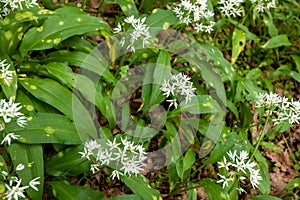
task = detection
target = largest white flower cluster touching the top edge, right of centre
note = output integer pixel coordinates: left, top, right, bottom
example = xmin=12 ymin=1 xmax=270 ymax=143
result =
xmin=173 ymin=0 xmax=215 ymax=33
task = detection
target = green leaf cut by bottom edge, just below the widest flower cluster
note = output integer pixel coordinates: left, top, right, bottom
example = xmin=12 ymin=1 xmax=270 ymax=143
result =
xmin=121 ymin=175 xmax=162 ymax=200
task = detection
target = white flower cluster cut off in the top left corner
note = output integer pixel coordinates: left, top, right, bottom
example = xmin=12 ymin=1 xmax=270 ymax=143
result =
xmin=0 ymin=0 xmax=39 ymax=18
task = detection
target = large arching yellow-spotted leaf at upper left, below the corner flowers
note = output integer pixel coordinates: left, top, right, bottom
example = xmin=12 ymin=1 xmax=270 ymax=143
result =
xmin=20 ymin=7 xmax=110 ymax=56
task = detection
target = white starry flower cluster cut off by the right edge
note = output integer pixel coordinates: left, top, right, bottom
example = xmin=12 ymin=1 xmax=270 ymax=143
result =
xmin=256 ymin=92 xmax=300 ymax=124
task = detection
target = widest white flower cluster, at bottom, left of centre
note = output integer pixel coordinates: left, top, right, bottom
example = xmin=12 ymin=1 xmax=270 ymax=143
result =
xmin=79 ymin=138 xmax=146 ymax=179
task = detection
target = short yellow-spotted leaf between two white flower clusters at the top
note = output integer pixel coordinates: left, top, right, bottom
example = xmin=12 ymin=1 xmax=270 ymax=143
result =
xmin=146 ymin=9 xmax=178 ymax=29
